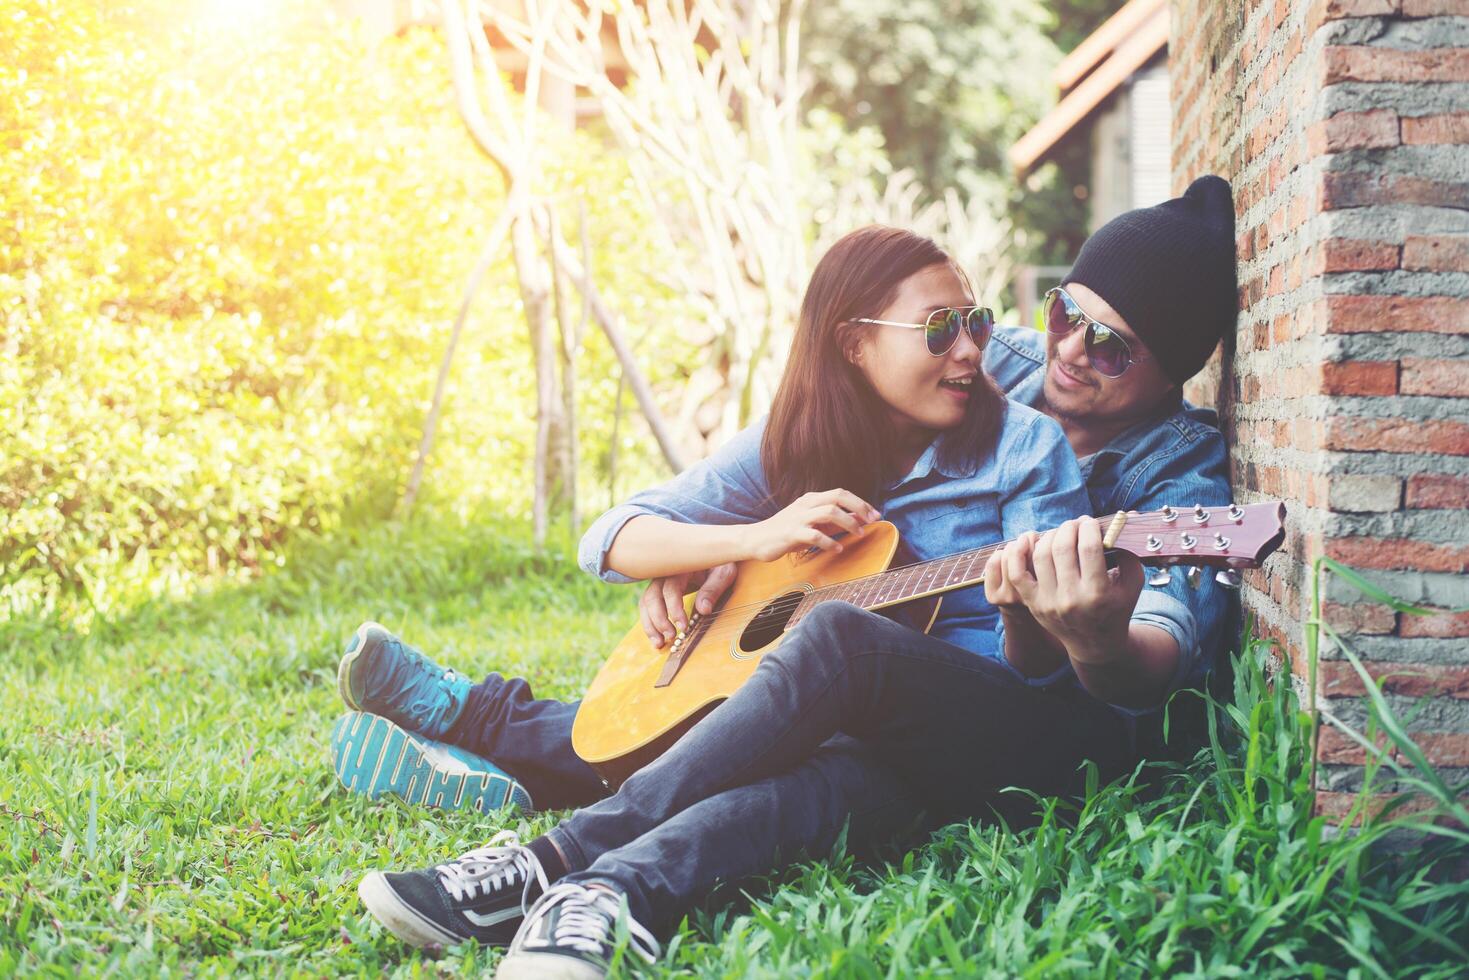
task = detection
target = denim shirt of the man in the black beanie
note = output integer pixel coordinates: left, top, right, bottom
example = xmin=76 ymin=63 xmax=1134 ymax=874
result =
xmin=984 ymin=326 xmax=1235 ymax=705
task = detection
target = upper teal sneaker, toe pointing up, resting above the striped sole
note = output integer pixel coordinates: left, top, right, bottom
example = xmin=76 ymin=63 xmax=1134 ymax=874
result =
xmin=336 ymin=623 xmax=473 ymax=739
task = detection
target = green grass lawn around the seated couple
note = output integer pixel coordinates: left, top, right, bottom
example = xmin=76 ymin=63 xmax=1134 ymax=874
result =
xmin=0 ymin=520 xmax=1469 ymax=977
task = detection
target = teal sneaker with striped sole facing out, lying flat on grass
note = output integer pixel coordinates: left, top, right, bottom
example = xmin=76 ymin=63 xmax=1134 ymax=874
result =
xmin=332 ymin=711 xmax=533 ymax=814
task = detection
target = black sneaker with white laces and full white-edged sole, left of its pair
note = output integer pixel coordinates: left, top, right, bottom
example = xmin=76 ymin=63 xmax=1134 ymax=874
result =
xmin=357 ymin=830 xmax=548 ymax=946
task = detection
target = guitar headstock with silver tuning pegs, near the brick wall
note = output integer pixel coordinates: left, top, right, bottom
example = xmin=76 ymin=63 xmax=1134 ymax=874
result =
xmin=1108 ymin=501 xmax=1285 ymax=569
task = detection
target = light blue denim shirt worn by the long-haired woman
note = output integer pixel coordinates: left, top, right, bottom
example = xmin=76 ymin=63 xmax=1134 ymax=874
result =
xmin=577 ymin=401 xmax=1090 ymax=663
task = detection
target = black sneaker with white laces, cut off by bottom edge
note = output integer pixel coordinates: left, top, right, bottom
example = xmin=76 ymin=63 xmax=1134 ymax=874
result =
xmin=495 ymin=882 xmax=658 ymax=980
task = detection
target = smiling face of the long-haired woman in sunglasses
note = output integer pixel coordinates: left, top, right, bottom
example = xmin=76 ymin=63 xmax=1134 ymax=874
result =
xmin=849 ymin=263 xmax=981 ymax=436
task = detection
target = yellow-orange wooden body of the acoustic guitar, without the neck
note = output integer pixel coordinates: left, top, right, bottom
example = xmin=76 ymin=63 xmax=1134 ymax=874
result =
xmin=571 ymin=522 xmax=942 ymax=788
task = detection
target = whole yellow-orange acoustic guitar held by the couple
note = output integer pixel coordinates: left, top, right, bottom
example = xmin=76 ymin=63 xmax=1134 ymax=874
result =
xmin=571 ymin=501 xmax=1285 ymax=789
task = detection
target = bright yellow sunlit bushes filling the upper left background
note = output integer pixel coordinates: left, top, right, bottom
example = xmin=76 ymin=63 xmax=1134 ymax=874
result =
xmin=0 ymin=0 xmax=692 ymax=619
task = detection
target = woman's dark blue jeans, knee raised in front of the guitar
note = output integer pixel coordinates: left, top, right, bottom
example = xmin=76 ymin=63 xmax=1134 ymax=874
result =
xmin=551 ymin=602 xmax=1153 ymax=927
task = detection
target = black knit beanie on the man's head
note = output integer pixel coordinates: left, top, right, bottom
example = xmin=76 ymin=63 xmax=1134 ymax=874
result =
xmin=1062 ymin=175 xmax=1238 ymax=385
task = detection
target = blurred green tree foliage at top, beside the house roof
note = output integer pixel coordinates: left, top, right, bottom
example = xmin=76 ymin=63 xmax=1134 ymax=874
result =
xmin=802 ymin=0 xmax=1122 ymax=276
